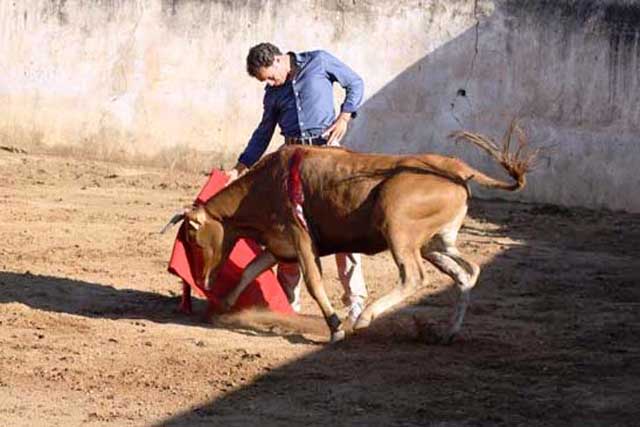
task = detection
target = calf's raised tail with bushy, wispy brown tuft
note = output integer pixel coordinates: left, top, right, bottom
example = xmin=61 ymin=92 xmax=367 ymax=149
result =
xmin=450 ymin=120 xmax=539 ymax=191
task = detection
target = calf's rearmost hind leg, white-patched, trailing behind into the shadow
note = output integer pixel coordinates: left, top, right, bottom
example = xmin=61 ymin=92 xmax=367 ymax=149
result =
xmin=421 ymin=235 xmax=480 ymax=342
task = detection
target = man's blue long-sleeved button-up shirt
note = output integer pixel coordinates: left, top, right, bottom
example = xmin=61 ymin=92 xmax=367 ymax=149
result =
xmin=238 ymin=50 xmax=364 ymax=166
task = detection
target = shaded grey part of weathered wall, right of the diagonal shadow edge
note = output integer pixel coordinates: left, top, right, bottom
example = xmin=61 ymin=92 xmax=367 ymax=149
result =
xmin=352 ymin=0 xmax=640 ymax=211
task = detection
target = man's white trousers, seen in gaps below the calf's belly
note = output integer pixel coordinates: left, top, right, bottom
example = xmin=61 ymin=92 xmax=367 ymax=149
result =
xmin=277 ymin=253 xmax=367 ymax=311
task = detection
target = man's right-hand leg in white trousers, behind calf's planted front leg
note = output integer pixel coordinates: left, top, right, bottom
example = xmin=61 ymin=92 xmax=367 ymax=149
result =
xmin=336 ymin=253 xmax=367 ymax=324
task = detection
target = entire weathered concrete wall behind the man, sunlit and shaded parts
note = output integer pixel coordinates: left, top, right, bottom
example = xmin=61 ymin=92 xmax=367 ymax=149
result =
xmin=0 ymin=0 xmax=640 ymax=212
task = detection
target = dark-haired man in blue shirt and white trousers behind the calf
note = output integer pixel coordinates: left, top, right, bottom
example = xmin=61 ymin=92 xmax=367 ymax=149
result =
xmin=228 ymin=43 xmax=367 ymax=322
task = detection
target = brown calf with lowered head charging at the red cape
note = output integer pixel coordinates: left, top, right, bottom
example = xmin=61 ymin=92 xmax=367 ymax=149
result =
xmin=166 ymin=125 xmax=533 ymax=341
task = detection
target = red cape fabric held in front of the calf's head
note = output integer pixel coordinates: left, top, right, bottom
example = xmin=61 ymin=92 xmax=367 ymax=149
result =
xmin=168 ymin=170 xmax=293 ymax=313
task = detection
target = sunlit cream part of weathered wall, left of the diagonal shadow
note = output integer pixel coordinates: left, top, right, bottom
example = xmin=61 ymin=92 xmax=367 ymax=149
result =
xmin=0 ymin=0 xmax=471 ymax=159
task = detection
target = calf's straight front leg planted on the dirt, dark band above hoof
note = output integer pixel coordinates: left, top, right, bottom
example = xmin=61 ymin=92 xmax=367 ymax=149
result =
xmin=293 ymin=226 xmax=345 ymax=342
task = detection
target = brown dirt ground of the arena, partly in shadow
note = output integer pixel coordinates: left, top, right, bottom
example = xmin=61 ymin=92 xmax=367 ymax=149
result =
xmin=0 ymin=151 xmax=640 ymax=427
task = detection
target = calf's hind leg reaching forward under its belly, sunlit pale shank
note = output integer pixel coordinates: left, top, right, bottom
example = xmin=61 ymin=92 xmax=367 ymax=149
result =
xmin=353 ymin=241 xmax=424 ymax=329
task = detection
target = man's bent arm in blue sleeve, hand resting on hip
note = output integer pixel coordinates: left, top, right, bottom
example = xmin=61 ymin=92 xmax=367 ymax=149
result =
xmin=322 ymin=52 xmax=364 ymax=145
